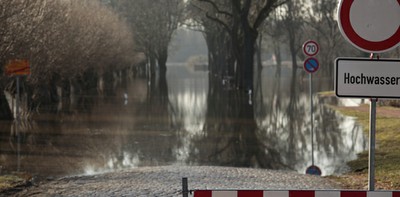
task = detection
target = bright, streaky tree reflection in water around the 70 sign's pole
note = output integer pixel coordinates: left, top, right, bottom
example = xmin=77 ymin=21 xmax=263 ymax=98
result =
xmin=256 ymin=68 xmax=365 ymax=174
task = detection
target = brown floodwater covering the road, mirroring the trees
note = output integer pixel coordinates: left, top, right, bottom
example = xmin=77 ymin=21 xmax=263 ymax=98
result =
xmin=0 ymin=65 xmax=367 ymax=177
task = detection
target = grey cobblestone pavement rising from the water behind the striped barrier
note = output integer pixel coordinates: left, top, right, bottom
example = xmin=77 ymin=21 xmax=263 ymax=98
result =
xmin=15 ymin=166 xmax=340 ymax=197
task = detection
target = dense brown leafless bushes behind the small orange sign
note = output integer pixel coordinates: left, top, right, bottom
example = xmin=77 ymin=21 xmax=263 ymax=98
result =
xmin=0 ymin=0 xmax=142 ymax=118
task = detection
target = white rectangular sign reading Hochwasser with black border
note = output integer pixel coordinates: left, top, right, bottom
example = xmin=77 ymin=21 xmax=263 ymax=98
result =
xmin=335 ymin=58 xmax=400 ymax=98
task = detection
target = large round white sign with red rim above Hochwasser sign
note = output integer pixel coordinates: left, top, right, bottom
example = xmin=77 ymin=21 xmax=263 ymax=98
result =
xmin=338 ymin=0 xmax=400 ymax=53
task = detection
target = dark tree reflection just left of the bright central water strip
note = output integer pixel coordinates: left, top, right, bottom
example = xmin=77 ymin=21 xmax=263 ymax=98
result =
xmin=124 ymin=75 xmax=179 ymax=166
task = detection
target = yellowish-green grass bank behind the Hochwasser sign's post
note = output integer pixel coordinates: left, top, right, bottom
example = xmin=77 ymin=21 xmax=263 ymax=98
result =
xmin=330 ymin=106 xmax=400 ymax=190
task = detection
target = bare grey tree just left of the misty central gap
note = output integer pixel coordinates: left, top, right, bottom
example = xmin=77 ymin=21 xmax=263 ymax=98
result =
xmin=111 ymin=0 xmax=185 ymax=76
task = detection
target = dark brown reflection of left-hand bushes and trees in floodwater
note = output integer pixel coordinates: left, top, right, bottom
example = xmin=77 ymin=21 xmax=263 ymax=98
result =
xmin=0 ymin=75 xmax=176 ymax=176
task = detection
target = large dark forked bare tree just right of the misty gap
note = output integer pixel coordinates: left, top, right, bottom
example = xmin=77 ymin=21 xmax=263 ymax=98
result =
xmin=192 ymin=0 xmax=286 ymax=90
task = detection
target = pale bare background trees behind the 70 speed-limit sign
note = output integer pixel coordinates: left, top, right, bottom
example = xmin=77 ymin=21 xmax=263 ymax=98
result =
xmin=263 ymin=0 xmax=359 ymax=76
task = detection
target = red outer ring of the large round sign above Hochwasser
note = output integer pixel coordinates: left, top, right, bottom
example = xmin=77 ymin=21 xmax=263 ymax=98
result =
xmin=338 ymin=0 xmax=400 ymax=53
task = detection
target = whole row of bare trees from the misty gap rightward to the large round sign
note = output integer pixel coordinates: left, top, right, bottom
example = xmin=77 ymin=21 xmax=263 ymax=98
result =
xmin=188 ymin=0 xmax=400 ymax=86
